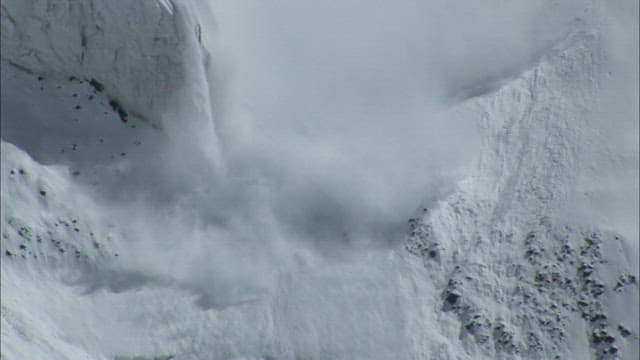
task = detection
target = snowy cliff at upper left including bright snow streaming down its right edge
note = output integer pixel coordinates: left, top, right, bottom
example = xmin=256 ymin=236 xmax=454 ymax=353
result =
xmin=2 ymin=0 xmax=224 ymax=167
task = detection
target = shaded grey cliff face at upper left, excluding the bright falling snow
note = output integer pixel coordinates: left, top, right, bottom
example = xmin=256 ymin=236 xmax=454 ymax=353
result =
xmin=2 ymin=1 xmax=191 ymax=126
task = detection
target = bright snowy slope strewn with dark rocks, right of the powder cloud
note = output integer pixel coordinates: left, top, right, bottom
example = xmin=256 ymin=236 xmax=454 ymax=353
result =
xmin=407 ymin=23 xmax=638 ymax=358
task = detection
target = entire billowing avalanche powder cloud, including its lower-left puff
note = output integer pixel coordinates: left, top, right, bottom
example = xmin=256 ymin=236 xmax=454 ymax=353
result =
xmin=94 ymin=0 xmax=637 ymax=307
